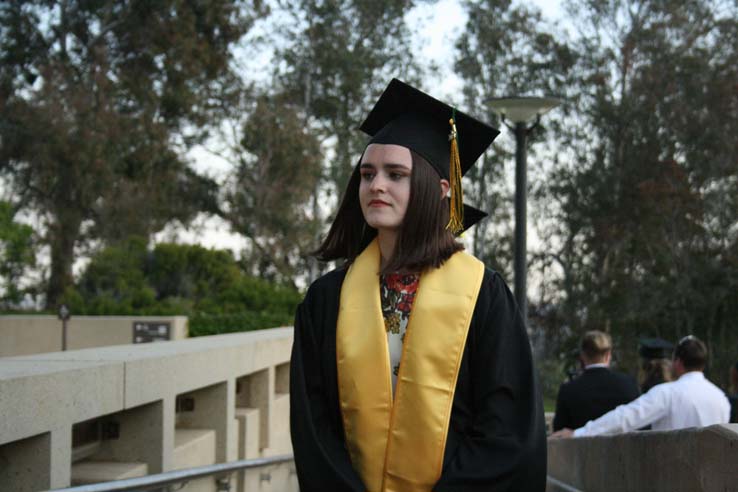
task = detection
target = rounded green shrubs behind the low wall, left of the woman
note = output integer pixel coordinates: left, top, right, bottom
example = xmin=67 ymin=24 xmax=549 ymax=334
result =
xmin=63 ymin=237 xmax=300 ymax=335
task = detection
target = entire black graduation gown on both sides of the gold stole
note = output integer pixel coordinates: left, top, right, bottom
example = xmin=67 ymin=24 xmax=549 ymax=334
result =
xmin=290 ymin=269 xmax=546 ymax=492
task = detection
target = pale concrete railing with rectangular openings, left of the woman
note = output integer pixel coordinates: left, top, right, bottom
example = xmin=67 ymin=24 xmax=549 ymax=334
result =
xmin=0 ymin=328 xmax=297 ymax=492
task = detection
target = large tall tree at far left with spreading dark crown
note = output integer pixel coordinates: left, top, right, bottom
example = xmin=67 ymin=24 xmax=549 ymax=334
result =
xmin=0 ymin=0 xmax=263 ymax=306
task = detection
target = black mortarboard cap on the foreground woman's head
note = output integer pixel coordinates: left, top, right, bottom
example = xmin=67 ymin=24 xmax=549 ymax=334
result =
xmin=360 ymin=79 xmax=500 ymax=179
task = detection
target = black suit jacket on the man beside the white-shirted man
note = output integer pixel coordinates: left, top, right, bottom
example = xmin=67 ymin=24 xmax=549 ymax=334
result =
xmin=553 ymin=367 xmax=640 ymax=430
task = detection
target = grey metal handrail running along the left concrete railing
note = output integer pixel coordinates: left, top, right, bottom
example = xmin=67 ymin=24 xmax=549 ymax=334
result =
xmin=53 ymin=454 xmax=294 ymax=492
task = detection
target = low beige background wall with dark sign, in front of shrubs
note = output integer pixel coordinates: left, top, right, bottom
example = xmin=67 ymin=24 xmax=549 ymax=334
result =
xmin=0 ymin=315 xmax=187 ymax=357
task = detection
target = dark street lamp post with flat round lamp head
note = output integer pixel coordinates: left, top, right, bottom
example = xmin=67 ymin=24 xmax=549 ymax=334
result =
xmin=489 ymin=97 xmax=560 ymax=324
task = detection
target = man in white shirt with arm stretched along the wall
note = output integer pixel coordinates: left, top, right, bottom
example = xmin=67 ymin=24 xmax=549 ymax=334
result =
xmin=551 ymin=335 xmax=730 ymax=438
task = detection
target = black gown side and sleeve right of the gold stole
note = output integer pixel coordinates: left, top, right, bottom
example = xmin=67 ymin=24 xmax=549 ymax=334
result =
xmin=433 ymin=270 xmax=546 ymax=492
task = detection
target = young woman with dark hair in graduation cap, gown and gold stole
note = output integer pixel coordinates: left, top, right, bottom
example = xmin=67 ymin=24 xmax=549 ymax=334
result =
xmin=290 ymin=79 xmax=546 ymax=492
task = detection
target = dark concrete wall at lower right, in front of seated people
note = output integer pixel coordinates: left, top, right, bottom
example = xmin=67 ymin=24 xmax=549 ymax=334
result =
xmin=548 ymin=424 xmax=738 ymax=492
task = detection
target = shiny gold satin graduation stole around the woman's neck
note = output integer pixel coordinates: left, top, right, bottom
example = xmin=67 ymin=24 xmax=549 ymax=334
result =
xmin=336 ymin=239 xmax=484 ymax=492
